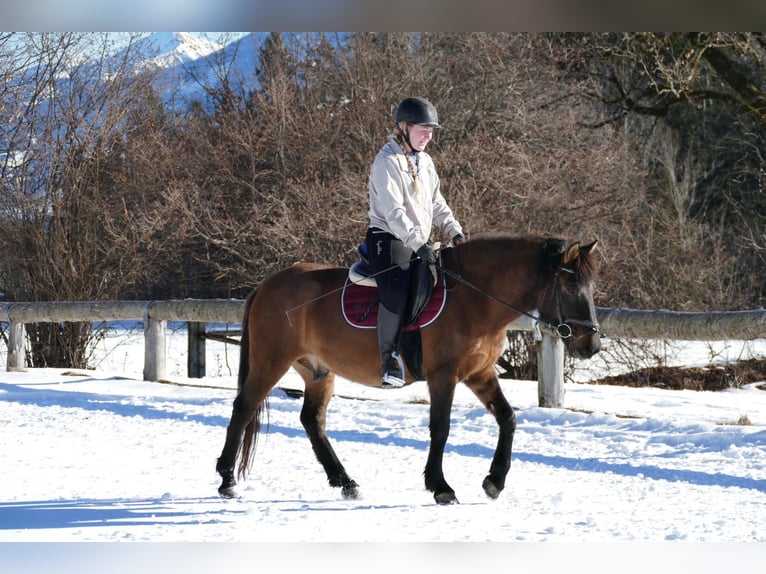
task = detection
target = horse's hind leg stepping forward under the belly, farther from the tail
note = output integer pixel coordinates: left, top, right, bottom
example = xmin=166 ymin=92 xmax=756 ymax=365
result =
xmin=295 ymin=361 xmax=359 ymax=499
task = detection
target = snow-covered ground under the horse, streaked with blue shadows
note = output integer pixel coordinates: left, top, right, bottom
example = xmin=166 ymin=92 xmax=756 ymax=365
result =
xmin=0 ymin=329 xmax=766 ymax=574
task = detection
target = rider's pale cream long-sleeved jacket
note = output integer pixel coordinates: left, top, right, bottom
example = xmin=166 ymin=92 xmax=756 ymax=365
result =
xmin=369 ymin=137 xmax=463 ymax=251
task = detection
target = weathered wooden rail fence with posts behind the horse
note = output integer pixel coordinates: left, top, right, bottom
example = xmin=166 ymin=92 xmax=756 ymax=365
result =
xmin=0 ymin=299 xmax=766 ymax=407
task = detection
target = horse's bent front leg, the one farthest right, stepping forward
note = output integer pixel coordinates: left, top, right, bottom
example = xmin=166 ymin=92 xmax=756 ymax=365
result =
xmin=465 ymin=374 xmax=516 ymax=498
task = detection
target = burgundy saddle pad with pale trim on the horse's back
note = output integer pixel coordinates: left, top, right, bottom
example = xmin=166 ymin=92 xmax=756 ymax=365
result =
xmin=340 ymin=271 xmax=447 ymax=331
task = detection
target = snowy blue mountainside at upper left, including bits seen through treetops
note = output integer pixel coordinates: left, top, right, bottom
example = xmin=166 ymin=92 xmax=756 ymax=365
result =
xmin=0 ymin=32 xmax=337 ymax=154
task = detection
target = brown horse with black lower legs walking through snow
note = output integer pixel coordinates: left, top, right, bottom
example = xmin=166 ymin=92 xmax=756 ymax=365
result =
xmin=216 ymin=233 xmax=601 ymax=504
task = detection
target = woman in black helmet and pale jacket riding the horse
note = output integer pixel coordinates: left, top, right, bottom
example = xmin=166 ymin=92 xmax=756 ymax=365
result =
xmin=365 ymin=97 xmax=465 ymax=388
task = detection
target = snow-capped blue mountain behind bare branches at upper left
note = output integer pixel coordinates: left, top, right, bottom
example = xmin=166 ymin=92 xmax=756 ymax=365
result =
xmin=0 ymin=32 xmax=260 ymax=173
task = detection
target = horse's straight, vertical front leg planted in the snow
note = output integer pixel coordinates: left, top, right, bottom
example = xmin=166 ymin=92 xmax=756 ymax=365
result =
xmin=424 ymin=376 xmax=458 ymax=504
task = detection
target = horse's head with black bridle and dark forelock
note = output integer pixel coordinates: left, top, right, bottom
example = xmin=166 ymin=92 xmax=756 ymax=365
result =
xmin=539 ymin=240 xmax=601 ymax=359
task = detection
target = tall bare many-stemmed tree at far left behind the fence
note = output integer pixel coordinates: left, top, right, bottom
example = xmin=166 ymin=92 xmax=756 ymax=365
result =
xmin=0 ymin=33 xmax=170 ymax=366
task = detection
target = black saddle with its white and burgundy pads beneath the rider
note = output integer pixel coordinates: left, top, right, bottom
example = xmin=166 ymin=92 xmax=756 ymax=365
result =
xmin=341 ymin=244 xmax=446 ymax=332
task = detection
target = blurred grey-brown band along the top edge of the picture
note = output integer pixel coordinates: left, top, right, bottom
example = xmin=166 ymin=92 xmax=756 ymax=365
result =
xmin=3 ymin=0 xmax=766 ymax=32
